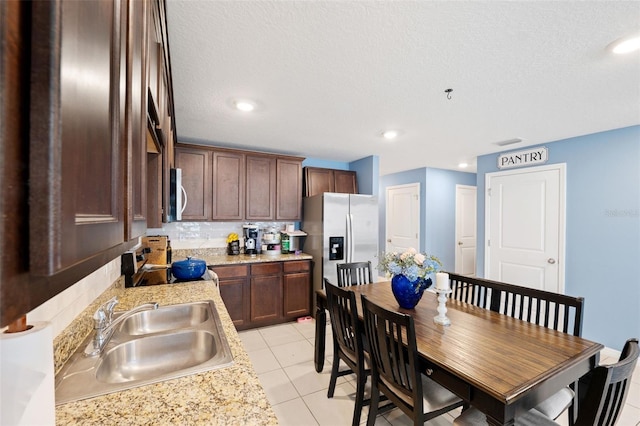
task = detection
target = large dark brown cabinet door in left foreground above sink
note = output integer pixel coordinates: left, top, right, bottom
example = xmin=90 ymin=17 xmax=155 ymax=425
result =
xmin=29 ymin=0 xmax=125 ymax=275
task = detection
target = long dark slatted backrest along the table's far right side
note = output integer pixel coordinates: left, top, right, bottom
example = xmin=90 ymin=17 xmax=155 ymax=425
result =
xmin=449 ymin=273 xmax=584 ymax=336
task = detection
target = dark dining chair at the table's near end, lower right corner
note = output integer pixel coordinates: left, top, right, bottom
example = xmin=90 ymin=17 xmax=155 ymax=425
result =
xmin=453 ymin=339 xmax=640 ymax=426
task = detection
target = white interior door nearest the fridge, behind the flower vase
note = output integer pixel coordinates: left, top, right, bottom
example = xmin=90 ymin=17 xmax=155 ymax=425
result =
xmin=385 ymin=183 xmax=420 ymax=253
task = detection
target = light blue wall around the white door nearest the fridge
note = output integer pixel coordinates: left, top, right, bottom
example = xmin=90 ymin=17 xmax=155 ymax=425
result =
xmin=379 ymin=168 xmax=476 ymax=271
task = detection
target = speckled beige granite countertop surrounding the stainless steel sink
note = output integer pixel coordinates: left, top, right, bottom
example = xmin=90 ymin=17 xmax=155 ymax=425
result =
xmin=54 ymin=280 xmax=278 ymax=425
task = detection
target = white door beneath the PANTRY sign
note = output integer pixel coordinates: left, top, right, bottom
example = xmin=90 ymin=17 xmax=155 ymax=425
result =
xmin=485 ymin=164 xmax=565 ymax=293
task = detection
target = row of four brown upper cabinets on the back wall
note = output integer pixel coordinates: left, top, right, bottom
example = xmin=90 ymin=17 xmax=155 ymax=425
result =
xmin=175 ymin=144 xmax=302 ymax=221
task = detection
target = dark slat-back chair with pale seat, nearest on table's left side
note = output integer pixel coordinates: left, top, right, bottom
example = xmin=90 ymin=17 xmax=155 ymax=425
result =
xmin=361 ymin=295 xmax=464 ymax=426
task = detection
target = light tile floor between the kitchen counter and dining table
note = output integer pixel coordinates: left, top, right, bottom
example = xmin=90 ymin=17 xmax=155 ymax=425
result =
xmin=239 ymin=321 xmax=640 ymax=426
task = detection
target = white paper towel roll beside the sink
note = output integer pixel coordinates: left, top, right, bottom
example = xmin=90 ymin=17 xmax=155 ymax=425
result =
xmin=0 ymin=322 xmax=56 ymax=425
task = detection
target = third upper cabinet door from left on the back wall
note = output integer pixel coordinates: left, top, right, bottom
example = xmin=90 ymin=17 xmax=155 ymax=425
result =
xmin=245 ymin=155 xmax=276 ymax=220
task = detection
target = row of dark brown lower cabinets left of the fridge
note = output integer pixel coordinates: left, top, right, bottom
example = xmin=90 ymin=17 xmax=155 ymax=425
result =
xmin=212 ymin=260 xmax=311 ymax=330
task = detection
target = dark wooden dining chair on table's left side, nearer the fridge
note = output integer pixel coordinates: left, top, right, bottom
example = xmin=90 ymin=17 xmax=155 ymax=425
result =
xmin=324 ymin=278 xmax=371 ymax=426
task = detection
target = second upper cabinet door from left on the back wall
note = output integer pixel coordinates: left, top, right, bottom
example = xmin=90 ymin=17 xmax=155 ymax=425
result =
xmin=214 ymin=151 xmax=245 ymax=220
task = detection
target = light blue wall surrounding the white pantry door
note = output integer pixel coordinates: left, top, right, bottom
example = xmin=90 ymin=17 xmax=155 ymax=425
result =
xmin=477 ymin=126 xmax=640 ymax=350
